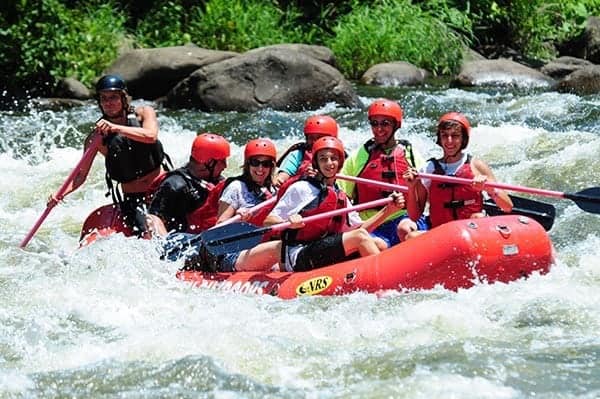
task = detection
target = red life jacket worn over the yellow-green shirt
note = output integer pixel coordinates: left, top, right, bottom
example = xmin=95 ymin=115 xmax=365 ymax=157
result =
xmin=354 ymin=139 xmax=415 ymax=203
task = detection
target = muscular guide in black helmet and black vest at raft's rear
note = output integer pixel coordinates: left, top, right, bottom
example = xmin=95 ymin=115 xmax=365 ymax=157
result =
xmin=48 ymin=75 xmax=170 ymax=236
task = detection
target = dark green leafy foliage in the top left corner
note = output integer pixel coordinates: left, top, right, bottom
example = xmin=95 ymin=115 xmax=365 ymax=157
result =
xmin=0 ymin=0 xmax=124 ymax=87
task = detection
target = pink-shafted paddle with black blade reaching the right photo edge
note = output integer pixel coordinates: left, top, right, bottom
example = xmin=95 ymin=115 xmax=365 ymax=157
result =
xmin=419 ymin=173 xmax=600 ymax=214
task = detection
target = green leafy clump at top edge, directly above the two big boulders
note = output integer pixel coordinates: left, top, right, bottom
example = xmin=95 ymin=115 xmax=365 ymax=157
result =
xmin=188 ymin=0 xmax=302 ymax=52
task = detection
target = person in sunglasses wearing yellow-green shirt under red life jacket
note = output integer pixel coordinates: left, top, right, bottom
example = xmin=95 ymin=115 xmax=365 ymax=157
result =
xmin=339 ymin=99 xmax=428 ymax=247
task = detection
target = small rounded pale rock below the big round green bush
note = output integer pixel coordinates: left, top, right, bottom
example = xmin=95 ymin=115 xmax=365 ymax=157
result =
xmin=360 ymin=61 xmax=429 ymax=86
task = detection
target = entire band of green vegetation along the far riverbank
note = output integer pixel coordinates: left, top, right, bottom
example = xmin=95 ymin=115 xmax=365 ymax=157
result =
xmin=0 ymin=0 xmax=600 ymax=94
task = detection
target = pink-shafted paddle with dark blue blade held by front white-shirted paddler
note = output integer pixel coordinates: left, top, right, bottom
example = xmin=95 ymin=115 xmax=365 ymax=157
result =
xmin=199 ymin=198 xmax=392 ymax=256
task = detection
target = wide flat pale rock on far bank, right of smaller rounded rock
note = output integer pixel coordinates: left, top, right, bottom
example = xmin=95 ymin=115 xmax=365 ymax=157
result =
xmin=453 ymin=59 xmax=556 ymax=88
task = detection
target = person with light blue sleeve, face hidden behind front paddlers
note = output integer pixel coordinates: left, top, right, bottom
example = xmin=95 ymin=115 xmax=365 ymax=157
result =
xmin=275 ymin=115 xmax=339 ymax=187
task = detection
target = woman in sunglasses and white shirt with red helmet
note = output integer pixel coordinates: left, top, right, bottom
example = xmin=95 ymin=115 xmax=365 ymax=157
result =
xmin=217 ymin=138 xmax=277 ymax=226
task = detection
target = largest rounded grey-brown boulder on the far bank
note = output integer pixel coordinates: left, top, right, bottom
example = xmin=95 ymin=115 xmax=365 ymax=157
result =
xmin=164 ymin=48 xmax=361 ymax=112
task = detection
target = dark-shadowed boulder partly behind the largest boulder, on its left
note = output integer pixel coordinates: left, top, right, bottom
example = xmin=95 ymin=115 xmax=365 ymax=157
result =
xmin=105 ymin=45 xmax=238 ymax=100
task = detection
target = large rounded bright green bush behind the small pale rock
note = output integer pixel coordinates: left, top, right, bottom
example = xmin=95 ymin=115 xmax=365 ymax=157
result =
xmin=329 ymin=0 xmax=463 ymax=78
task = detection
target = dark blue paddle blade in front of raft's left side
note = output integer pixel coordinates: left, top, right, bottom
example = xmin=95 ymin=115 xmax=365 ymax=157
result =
xmin=199 ymin=222 xmax=271 ymax=256
